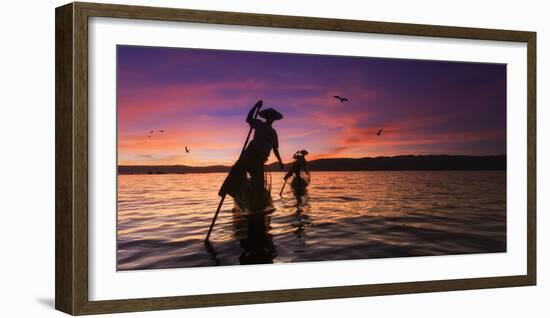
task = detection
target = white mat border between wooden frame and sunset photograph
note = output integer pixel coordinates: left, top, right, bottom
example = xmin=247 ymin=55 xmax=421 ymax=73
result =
xmin=88 ymin=17 xmax=527 ymax=301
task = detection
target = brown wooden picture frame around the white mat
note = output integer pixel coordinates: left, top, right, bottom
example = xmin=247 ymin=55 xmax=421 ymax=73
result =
xmin=55 ymin=2 xmax=536 ymax=315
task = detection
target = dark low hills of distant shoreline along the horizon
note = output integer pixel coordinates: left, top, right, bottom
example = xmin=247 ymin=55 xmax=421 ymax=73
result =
xmin=118 ymin=155 xmax=506 ymax=175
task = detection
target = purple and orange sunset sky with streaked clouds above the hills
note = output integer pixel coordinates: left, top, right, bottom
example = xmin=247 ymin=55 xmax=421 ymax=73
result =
xmin=117 ymin=46 xmax=506 ymax=166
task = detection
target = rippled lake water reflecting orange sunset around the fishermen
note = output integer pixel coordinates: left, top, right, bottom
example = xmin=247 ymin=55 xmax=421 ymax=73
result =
xmin=117 ymin=171 xmax=506 ymax=270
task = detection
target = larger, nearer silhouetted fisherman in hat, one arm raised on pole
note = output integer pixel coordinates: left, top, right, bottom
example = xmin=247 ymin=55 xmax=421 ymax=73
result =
xmin=218 ymin=102 xmax=284 ymax=211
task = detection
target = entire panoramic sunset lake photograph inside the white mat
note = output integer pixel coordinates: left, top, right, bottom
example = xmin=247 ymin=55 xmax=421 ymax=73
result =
xmin=116 ymin=45 xmax=507 ymax=271
